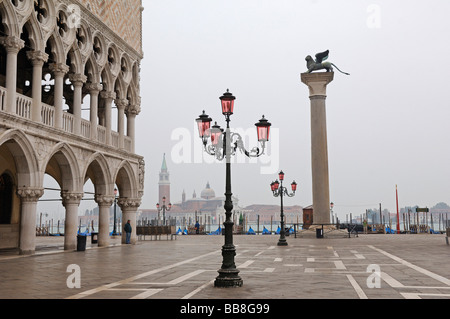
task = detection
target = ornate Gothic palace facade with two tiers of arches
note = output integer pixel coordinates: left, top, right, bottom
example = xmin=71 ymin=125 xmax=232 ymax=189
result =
xmin=0 ymin=0 xmax=144 ymax=254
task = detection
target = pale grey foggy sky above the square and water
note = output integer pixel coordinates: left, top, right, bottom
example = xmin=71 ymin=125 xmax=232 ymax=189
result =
xmin=39 ymin=0 xmax=450 ymax=218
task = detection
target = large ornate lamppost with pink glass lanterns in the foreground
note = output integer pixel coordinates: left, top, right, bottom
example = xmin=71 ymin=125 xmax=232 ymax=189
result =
xmin=197 ymin=90 xmax=271 ymax=287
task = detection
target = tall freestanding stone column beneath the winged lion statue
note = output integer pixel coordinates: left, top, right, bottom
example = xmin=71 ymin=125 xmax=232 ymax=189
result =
xmin=301 ymin=72 xmax=334 ymax=227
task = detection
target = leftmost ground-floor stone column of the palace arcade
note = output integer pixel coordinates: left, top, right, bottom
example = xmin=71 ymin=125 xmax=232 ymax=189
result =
xmin=17 ymin=187 xmax=44 ymax=255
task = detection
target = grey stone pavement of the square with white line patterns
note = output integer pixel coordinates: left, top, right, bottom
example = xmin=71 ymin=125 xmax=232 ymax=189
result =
xmin=0 ymin=234 xmax=450 ymax=308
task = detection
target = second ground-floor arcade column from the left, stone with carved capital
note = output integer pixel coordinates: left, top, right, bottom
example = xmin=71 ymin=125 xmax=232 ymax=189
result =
xmin=61 ymin=192 xmax=83 ymax=250
